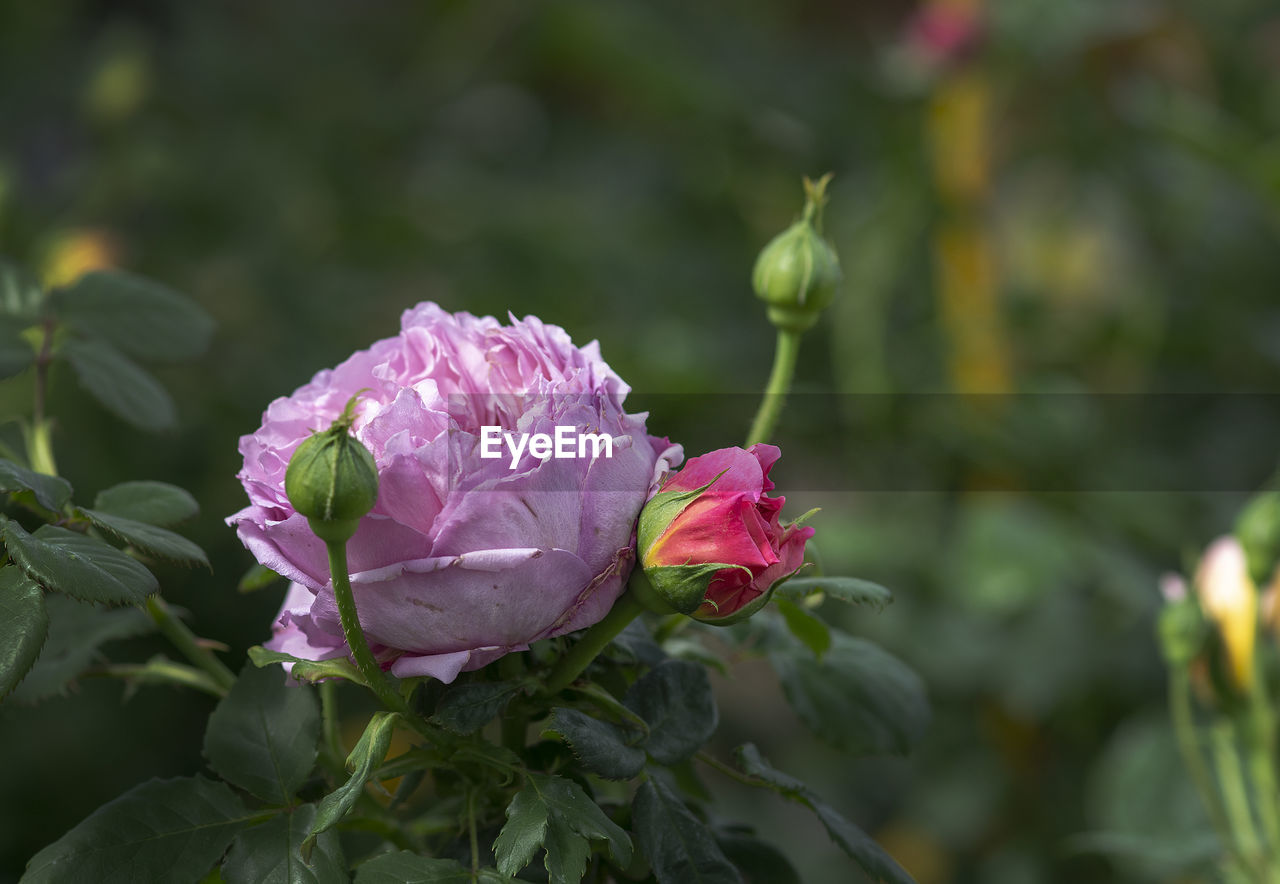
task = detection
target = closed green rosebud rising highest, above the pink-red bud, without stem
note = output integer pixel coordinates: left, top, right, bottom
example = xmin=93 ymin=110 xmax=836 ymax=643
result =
xmin=751 ymin=173 xmax=842 ymax=331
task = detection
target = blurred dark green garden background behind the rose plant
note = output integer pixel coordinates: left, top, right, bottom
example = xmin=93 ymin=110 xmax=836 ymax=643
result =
xmin=0 ymin=0 xmax=1280 ymax=884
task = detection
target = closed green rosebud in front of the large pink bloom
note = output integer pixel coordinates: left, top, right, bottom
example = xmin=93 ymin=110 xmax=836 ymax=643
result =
xmin=284 ymin=394 xmax=378 ymax=544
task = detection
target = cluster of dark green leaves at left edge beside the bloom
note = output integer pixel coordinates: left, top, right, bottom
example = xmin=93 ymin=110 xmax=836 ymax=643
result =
xmin=0 ymin=260 xmax=215 ymax=702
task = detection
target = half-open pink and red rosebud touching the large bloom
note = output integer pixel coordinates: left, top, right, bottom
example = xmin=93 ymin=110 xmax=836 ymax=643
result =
xmin=637 ymin=445 xmax=813 ymax=626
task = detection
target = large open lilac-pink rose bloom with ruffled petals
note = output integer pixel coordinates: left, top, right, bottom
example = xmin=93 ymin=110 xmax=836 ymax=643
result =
xmin=228 ymin=303 xmax=682 ymax=682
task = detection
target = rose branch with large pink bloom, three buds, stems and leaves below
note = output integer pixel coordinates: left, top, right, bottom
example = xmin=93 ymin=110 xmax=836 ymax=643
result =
xmin=10 ymin=179 xmax=928 ymax=884
